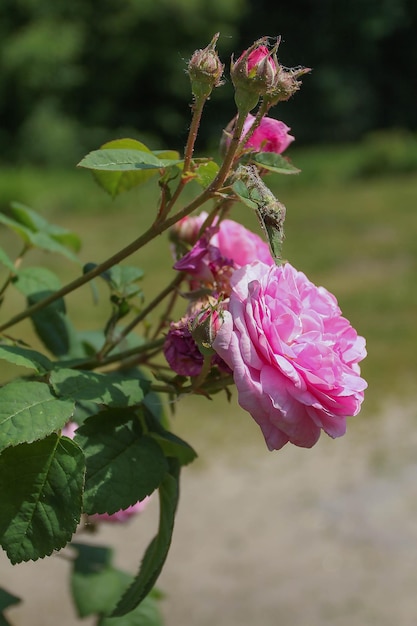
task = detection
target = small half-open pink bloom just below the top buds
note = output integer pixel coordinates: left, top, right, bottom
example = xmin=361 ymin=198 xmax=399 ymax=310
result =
xmin=242 ymin=114 xmax=294 ymax=154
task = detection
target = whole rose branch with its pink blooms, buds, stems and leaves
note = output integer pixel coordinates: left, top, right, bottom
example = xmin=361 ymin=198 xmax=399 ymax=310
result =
xmin=0 ymin=34 xmax=366 ymax=626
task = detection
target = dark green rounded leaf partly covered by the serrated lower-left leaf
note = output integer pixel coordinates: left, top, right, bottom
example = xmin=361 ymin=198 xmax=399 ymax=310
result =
xmin=75 ymin=410 xmax=167 ymax=515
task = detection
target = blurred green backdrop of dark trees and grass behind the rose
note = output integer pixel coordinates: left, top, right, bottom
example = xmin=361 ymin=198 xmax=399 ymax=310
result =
xmin=0 ymin=0 xmax=417 ymax=420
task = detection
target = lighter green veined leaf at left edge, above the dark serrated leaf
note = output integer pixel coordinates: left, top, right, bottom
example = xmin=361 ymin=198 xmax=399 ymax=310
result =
xmin=0 ymin=381 xmax=74 ymax=451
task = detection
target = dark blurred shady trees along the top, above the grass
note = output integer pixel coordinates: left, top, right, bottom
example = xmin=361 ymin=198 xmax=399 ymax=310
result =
xmin=0 ymin=0 xmax=417 ymax=165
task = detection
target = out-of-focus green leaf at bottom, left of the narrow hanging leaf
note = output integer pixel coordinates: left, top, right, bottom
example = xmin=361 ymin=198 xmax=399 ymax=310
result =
xmin=71 ymin=542 xmax=133 ymax=618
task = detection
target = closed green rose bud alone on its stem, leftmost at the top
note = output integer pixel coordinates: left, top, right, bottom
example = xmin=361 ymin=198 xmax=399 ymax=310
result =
xmin=188 ymin=33 xmax=224 ymax=98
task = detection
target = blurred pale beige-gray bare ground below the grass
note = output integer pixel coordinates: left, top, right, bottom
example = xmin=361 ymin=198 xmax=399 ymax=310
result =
xmin=0 ymin=402 xmax=417 ymax=626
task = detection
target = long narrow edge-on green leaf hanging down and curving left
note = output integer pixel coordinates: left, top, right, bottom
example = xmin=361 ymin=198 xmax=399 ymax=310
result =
xmin=112 ymin=460 xmax=180 ymax=616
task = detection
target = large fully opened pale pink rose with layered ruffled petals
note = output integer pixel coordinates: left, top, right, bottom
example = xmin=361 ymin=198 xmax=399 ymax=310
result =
xmin=213 ymin=262 xmax=367 ymax=450
